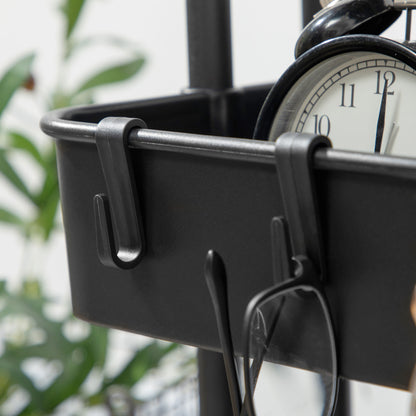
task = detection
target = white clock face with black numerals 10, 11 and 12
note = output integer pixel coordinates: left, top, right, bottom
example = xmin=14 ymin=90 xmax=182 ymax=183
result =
xmin=270 ymin=52 xmax=416 ymax=156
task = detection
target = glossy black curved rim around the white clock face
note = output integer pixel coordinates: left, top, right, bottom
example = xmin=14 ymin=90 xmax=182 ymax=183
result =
xmin=253 ymin=35 xmax=416 ymax=140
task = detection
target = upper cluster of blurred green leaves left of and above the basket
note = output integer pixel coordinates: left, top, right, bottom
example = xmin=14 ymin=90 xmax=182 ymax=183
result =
xmin=0 ymin=0 xmax=145 ymax=241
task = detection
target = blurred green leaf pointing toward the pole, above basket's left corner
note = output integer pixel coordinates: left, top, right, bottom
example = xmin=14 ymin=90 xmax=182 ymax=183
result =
xmin=74 ymin=56 xmax=145 ymax=95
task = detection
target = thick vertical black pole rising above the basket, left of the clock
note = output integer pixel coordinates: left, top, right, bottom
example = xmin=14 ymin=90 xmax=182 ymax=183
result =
xmin=187 ymin=0 xmax=233 ymax=90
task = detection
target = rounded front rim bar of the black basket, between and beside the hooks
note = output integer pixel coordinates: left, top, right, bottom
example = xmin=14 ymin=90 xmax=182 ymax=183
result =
xmin=41 ymin=110 xmax=416 ymax=180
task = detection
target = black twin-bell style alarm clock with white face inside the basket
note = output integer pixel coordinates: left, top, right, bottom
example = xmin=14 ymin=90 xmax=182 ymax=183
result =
xmin=254 ymin=0 xmax=416 ymax=156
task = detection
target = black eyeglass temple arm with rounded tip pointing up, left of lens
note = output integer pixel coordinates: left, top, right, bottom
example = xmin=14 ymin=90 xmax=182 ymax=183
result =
xmin=205 ymin=250 xmax=242 ymax=416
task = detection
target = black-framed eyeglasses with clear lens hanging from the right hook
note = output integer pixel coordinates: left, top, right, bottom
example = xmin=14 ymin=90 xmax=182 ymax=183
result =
xmin=205 ymin=217 xmax=338 ymax=416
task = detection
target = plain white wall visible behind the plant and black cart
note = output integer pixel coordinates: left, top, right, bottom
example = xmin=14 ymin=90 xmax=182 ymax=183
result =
xmin=0 ymin=0 xmax=412 ymax=416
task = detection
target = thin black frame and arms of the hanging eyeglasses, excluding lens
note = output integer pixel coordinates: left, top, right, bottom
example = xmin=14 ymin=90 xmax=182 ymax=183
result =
xmin=205 ymin=217 xmax=338 ymax=416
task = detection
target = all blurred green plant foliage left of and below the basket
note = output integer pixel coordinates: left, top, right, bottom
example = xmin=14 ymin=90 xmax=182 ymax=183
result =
xmin=0 ymin=0 xmax=192 ymax=416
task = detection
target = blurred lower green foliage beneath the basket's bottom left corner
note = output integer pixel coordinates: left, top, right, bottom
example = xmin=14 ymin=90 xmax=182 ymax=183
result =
xmin=0 ymin=281 xmax=182 ymax=416
